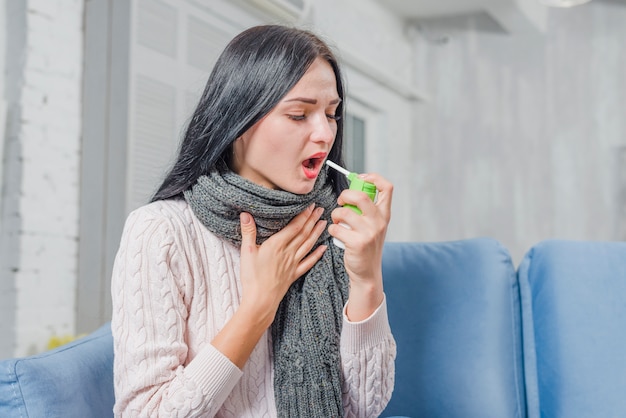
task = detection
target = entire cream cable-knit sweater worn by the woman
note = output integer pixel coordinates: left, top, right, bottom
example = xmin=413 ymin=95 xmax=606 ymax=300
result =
xmin=111 ymin=200 xmax=396 ymax=418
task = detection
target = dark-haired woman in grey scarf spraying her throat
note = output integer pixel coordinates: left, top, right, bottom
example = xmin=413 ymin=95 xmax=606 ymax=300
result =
xmin=112 ymin=26 xmax=395 ymax=417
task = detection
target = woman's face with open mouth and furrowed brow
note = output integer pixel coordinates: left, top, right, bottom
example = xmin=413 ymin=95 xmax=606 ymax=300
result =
xmin=232 ymin=58 xmax=340 ymax=194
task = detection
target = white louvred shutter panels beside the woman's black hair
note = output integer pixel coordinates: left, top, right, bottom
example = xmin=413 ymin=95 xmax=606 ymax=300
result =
xmin=126 ymin=0 xmax=236 ymax=211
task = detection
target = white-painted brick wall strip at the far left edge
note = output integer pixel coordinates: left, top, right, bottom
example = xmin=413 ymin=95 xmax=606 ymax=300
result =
xmin=0 ymin=0 xmax=83 ymax=356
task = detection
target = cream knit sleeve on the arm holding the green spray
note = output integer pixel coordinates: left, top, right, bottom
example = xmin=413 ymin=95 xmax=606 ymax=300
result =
xmin=341 ymin=298 xmax=396 ymax=417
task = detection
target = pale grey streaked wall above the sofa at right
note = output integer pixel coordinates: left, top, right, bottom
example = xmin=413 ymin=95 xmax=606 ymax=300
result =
xmin=411 ymin=0 xmax=626 ymax=262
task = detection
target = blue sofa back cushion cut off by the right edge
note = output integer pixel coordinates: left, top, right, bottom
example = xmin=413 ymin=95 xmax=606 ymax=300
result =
xmin=519 ymin=240 xmax=626 ymax=418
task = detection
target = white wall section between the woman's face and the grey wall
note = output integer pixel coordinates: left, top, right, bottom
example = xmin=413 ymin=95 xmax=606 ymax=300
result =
xmin=313 ymin=0 xmax=422 ymax=241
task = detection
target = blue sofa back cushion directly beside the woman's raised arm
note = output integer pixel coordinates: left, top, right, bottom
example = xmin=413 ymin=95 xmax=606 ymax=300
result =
xmin=382 ymin=239 xmax=526 ymax=418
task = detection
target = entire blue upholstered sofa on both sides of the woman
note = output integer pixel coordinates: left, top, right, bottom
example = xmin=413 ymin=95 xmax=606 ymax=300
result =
xmin=0 ymin=239 xmax=626 ymax=418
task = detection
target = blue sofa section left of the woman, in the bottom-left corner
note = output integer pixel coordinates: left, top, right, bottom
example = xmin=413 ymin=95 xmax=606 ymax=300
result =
xmin=0 ymin=324 xmax=114 ymax=418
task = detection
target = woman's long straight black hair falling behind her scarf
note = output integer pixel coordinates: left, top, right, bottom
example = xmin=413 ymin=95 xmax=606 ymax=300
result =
xmin=152 ymin=25 xmax=347 ymax=201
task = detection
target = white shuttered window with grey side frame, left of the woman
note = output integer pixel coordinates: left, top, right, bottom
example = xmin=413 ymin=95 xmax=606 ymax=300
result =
xmin=80 ymin=0 xmax=239 ymax=332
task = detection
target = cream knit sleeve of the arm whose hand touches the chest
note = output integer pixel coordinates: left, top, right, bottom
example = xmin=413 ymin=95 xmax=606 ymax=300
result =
xmin=111 ymin=208 xmax=242 ymax=417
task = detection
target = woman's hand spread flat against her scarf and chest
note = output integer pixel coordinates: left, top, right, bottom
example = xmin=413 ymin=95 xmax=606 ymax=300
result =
xmin=240 ymin=205 xmax=327 ymax=327
